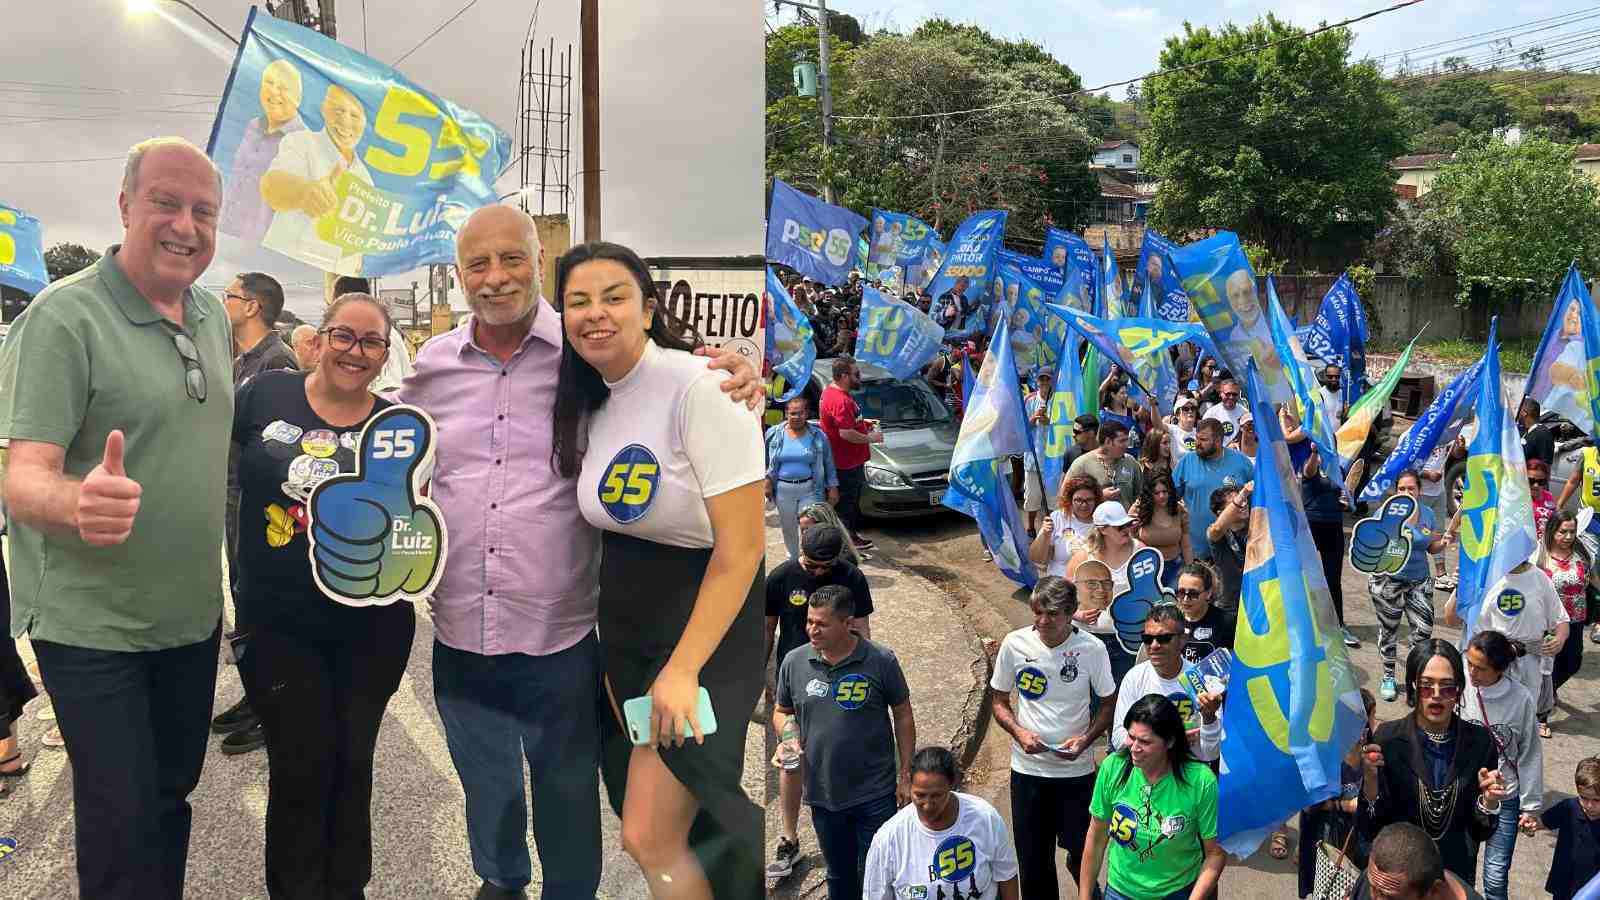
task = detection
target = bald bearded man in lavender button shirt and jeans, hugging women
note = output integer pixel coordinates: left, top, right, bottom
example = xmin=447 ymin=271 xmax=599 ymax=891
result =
xmin=398 ymin=207 xmax=762 ymax=900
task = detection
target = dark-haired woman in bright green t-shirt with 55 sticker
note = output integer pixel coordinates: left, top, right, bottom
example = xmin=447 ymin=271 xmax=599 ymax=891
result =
xmin=1078 ymin=693 xmax=1224 ymax=900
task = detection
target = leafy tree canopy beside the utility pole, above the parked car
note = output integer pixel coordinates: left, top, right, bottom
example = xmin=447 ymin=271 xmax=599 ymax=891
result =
xmin=766 ymin=19 xmax=1099 ymax=243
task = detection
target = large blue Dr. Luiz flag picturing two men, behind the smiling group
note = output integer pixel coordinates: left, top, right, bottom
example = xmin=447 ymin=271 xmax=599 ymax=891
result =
xmin=206 ymin=8 xmax=510 ymax=277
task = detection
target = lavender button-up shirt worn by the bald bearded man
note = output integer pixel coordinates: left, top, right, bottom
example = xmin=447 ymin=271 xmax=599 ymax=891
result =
xmin=398 ymin=298 xmax=600 ymax=655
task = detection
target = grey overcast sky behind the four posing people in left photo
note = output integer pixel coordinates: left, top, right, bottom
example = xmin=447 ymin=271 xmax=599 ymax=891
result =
xmin=0 ymin=0 xmax=762 ymax=317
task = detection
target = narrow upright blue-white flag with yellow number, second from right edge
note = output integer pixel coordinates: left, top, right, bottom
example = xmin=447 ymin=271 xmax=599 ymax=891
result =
xmin=1456 ymin=319 xmax=1539 ymax=627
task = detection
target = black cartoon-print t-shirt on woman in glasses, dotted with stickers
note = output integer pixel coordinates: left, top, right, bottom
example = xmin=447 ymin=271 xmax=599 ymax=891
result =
xmin=234 ymin=372 xmax=390 ymax=636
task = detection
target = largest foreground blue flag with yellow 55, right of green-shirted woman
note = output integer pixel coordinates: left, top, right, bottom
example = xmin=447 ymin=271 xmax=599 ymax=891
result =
xmin=1216 ymin=360 xmax=1366 ymax=857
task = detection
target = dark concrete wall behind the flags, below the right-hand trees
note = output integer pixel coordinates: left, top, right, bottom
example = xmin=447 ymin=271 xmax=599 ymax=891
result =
xmin=1261 ymin=275 xmax=1555 ymax=344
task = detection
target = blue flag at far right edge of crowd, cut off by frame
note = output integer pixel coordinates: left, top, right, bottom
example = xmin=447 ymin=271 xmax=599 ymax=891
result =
xmin=1523 ymin=263 xmax=1600 ymax=434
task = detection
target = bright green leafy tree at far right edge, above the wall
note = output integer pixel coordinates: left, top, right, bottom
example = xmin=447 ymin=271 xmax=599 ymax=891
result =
xmin=1426 ymin=138 xmax=1600 ymax=311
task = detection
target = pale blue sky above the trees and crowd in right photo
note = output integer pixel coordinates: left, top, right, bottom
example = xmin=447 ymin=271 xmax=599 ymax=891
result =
xmin=800 ymin=0 xmax=1561 ymax=89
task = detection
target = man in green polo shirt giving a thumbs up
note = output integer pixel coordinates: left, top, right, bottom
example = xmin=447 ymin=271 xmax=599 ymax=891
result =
xmin=0 ymin=138 xmax=234 ymax=900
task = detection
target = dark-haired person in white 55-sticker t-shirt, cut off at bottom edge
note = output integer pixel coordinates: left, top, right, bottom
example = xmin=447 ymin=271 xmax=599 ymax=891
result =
xmin=862 ymin=746 xmax=1021 ymax=900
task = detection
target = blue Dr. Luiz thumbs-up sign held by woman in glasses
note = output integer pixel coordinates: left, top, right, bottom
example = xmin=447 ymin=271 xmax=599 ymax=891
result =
xmin=306 ymin=405 xmax=445 ymax=605
